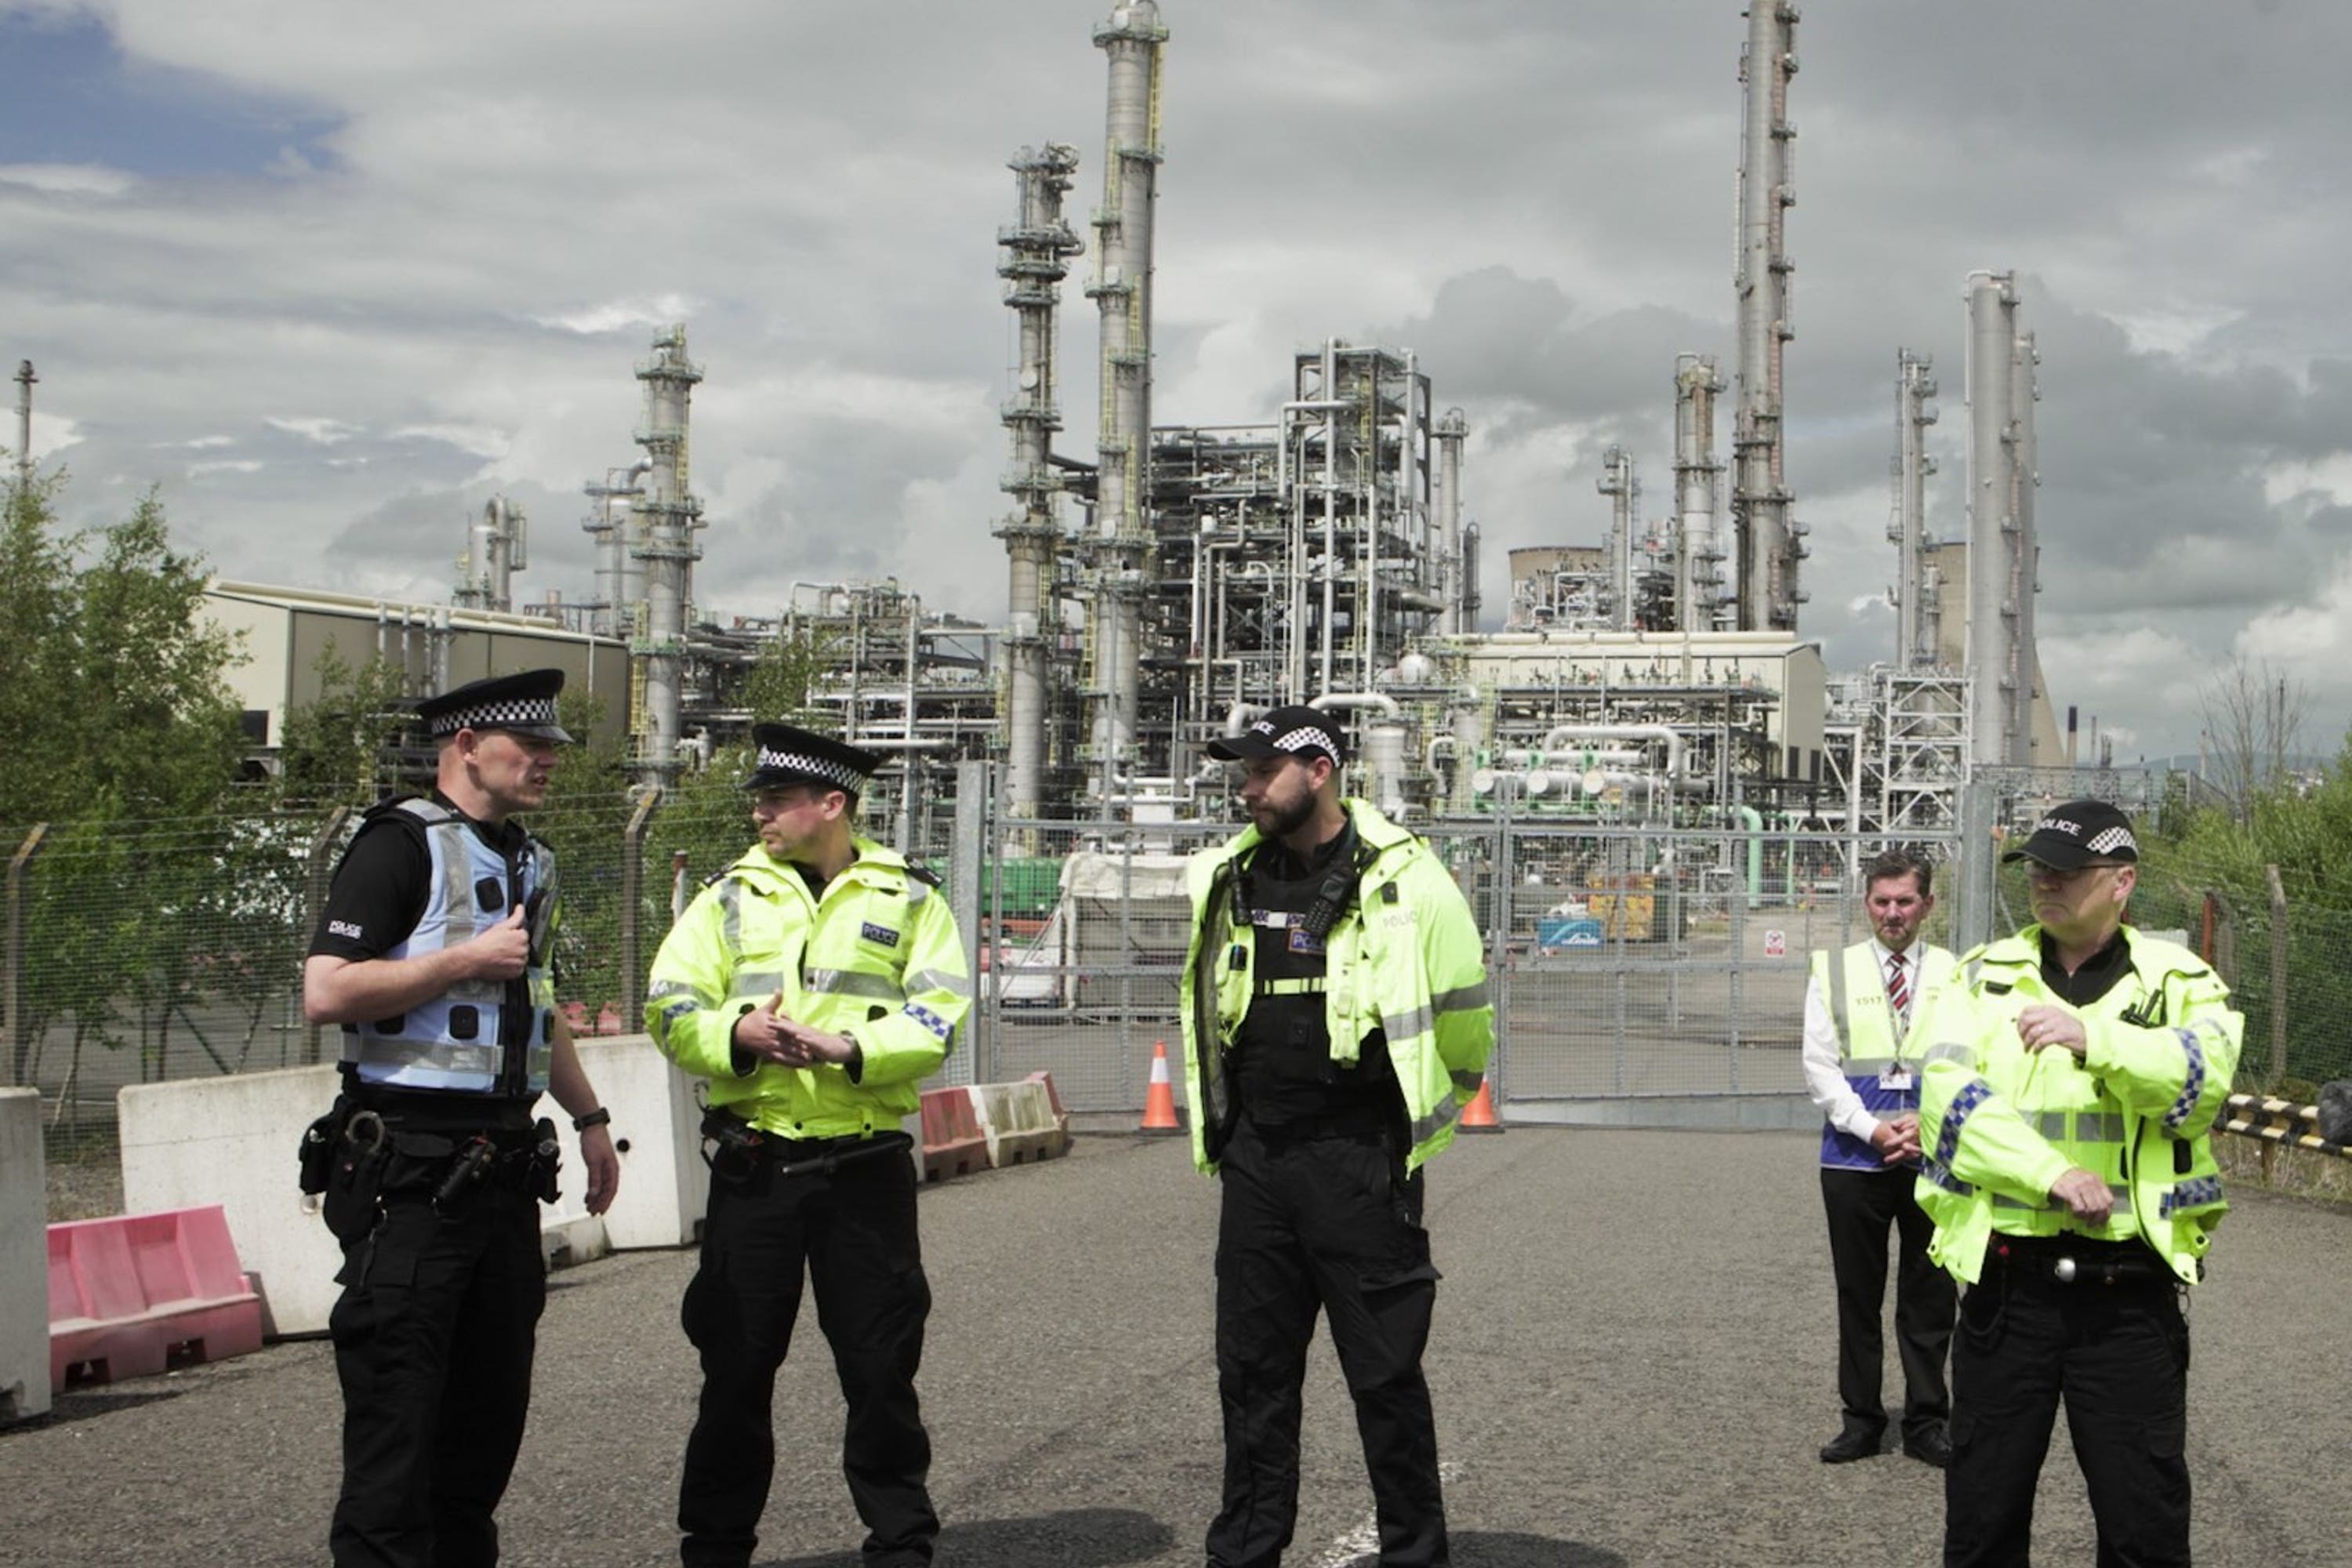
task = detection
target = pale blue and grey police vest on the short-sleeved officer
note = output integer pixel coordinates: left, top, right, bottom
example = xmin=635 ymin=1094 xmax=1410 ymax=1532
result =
xmin=343 ymin=799 xmax=555 ymax=1095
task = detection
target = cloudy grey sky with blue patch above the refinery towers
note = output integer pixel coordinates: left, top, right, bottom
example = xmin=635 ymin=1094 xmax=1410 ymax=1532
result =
xmin=0 ymin=0 xmax=2352 ymax=760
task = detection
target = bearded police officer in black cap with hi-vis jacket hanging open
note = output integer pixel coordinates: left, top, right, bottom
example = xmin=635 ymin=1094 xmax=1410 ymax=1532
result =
xmin=1183 ymin=708 xmax=1494 ymax=1568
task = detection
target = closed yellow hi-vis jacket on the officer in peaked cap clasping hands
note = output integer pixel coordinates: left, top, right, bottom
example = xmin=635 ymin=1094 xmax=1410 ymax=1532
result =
xmin=644 ymin=837 xmax=971 ymax=1138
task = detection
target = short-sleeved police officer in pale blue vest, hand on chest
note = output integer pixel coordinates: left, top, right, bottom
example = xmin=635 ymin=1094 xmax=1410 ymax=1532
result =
xmin=303 ymin=670 xmax=621 ymax=1568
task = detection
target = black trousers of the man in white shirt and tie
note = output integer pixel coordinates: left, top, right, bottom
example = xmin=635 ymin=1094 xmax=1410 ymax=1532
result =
xmin=1820 ymin=1166 xmax=1959 ymax=1436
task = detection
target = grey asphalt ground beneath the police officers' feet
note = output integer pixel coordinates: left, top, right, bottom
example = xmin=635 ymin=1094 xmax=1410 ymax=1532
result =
xmin=0 ymin=1128 xmax=2352 ymax=1568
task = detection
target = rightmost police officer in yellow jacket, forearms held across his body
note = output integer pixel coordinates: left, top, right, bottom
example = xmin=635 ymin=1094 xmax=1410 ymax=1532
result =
xmin=1915 ymin=799 xmax=2244 ymax=1566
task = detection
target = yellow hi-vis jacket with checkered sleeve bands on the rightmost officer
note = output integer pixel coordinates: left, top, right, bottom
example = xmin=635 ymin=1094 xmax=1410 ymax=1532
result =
xmin=1912 ymin=926 xmax=2246 ymax=1283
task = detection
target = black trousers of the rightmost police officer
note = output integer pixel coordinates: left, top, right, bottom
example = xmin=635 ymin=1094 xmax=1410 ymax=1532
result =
xmin=1943 ymin=1236 xmax=2190 ymax=1568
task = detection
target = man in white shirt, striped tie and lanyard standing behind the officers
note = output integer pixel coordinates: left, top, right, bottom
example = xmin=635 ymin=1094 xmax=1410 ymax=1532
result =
xmin=1804 ymin=848 xmax=1955 ymax=1467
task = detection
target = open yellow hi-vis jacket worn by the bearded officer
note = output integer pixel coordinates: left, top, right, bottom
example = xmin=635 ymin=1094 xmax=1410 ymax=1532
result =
xmin=1178 ymin=799 xmax=1494 ymax=1171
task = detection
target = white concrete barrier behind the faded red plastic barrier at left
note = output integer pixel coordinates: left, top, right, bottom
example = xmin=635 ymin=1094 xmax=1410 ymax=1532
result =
xmin=115 ymin=1067 xmax=343 ymax=1335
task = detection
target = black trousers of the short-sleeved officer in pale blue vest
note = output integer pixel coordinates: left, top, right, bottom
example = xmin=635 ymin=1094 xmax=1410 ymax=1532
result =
xmin=327 ymin=1187 xmax=548 ymax=1568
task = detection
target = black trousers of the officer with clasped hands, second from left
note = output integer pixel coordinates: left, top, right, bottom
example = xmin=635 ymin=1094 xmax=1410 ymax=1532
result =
xmin=677 ymin=1149 xmax=938 ymax=1568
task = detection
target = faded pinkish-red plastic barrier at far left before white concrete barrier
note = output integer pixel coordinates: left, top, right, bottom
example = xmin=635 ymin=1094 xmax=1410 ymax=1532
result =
xmin=49 ymin=1203 xmax=261 ymax=1389
